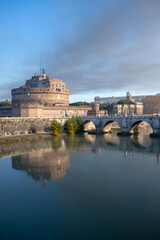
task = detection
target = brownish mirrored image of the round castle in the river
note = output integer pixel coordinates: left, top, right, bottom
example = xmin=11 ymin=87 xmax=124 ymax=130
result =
xmin=12 ymin=149 xmax=70 ymax=182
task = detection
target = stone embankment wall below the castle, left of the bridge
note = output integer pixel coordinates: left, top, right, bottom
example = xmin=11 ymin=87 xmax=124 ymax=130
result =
xmin=0 ymin=117 xmax=68 ymax=135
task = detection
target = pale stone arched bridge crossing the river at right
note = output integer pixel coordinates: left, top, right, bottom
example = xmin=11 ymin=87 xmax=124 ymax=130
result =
xmin=83 ymin=115 xmax=160 ymax=136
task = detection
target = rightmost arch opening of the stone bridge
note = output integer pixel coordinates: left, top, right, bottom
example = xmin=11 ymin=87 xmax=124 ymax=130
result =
xmin=130 ymin=120 xmax=153 ymax=134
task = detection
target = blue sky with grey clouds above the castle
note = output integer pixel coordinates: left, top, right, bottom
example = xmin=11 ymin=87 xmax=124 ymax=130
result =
xmin=0 ymin=0 xmax=160 ymax=102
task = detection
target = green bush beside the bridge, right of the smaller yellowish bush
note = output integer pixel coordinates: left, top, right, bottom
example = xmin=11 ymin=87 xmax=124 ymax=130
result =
xmin=64 ymin=117 xmax=84 ymax=134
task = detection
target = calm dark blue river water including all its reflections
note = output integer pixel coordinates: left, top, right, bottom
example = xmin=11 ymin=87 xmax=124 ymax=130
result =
xmin=0 ymin=133 xmax=160 ymax=240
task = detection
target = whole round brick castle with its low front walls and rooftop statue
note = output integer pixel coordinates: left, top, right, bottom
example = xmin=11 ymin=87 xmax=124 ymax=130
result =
xmin=11 ymin=70 xmax=91 ymax=117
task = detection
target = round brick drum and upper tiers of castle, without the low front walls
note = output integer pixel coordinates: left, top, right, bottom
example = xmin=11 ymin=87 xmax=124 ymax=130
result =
xmin=11 ymin=70 xmax=69 ymax=117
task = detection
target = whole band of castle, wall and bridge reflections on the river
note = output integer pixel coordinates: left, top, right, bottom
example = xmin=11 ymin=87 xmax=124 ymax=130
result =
xmin=0 ymin=133 xmax=160 ymax=183
